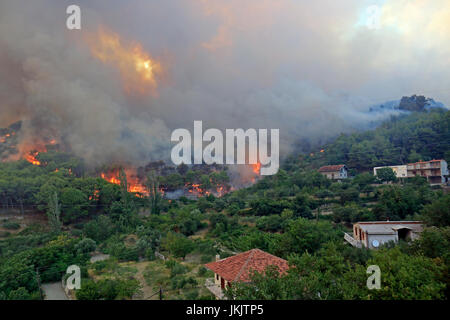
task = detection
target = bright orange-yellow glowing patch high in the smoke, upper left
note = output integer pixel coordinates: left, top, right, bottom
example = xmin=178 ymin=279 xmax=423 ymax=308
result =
xmin=86 ymin=28 xmax=162 ymax=94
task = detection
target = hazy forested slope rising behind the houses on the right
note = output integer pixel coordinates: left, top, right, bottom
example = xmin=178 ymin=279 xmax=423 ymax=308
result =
xmin=305 ymin=109 xmax=450 ymax=171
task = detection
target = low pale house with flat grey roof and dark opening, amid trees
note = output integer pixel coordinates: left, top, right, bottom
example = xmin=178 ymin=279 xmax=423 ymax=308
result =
xmin=344 ymin=221 xmax=423 ymax=249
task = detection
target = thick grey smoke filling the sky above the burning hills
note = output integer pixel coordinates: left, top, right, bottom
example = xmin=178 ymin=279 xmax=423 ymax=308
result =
xmin=0 ymin=0 xmax=450 ymax=168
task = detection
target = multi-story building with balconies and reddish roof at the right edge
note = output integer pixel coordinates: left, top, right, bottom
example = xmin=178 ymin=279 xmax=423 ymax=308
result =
xmin=407 ymin=160 xmax=449 ymax=185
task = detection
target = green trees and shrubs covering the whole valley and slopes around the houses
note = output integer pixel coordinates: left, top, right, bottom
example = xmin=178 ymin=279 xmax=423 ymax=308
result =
xmin=0 ymin=110 xmax=450 ymax=299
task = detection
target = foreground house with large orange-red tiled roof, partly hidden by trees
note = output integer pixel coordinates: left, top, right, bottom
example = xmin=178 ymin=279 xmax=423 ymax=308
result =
xmin=205 ymin=249 xmax=289 ymax=296
